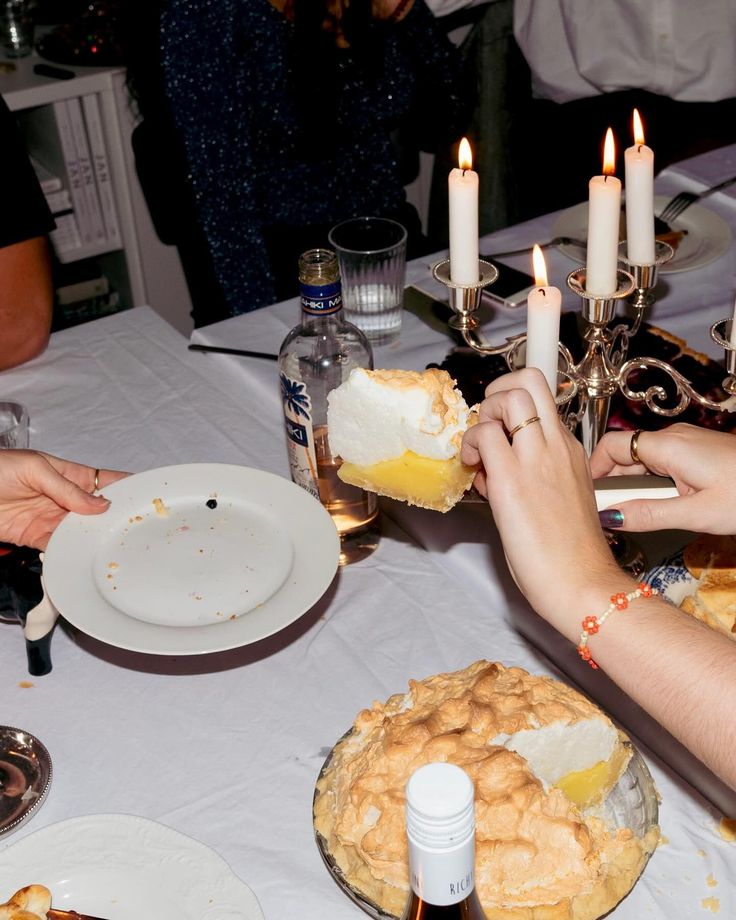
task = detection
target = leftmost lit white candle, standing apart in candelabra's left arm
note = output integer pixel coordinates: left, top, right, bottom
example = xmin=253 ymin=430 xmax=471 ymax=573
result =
xmin=448 ymin=137 xmax=479 ymax=285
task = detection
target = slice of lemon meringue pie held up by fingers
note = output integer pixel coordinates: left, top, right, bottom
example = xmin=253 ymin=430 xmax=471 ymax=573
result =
xmin=327 ymin=368 xmax=477 ymax=511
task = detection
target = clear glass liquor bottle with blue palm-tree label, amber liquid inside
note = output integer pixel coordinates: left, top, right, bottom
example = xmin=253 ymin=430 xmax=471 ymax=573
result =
xmin=279 ymin=249 xmax=379 ymax=565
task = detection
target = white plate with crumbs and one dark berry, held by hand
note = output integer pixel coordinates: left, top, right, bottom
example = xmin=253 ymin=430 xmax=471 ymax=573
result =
xmin=43 ymin=463 xmax=340 ymax=655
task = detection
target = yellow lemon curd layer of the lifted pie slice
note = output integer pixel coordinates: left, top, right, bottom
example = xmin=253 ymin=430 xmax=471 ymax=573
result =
xmin=337 ymin=450 xmax=475 ymax=511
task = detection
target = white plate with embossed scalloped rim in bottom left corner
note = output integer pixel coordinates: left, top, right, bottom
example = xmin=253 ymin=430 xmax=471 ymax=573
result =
xmin=0 ymin=814 xmax=263 ymax=920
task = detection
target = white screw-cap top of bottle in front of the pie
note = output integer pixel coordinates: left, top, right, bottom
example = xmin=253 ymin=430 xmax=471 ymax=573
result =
xmin=406 ymin=763 xmax=475 ymax=850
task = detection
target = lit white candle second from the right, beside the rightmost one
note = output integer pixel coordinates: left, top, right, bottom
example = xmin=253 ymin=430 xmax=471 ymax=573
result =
xmin=585 ymin=128 xmax=621 ymax=297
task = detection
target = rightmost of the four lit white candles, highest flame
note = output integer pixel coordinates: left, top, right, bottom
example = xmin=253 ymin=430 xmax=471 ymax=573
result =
xmin=624 ymin=109 xmax=654 ymax=265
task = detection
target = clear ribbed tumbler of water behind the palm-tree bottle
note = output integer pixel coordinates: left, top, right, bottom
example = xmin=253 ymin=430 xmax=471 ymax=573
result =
xmin=329 ymin=217 xmax=406 ymax=345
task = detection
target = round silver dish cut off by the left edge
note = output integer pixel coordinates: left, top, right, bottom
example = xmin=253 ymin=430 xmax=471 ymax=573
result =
xmin=0 ymin=725 xmax=53 ymax=836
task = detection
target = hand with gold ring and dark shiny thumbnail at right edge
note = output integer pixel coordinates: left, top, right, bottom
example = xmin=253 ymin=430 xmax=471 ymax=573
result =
xmin=590 ymin=424 xmax=736 ymax=534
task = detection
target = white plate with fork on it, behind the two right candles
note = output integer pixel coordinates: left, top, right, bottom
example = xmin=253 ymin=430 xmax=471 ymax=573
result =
xmin=552 ymin=195 xmax=732 ymax=274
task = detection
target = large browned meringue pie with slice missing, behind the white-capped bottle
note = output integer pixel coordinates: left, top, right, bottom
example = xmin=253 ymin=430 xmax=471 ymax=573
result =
xmin=314 ymin=661 xmax=658 ymax=920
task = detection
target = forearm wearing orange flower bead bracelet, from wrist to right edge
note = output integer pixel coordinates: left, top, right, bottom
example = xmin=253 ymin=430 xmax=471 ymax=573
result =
xmin=558 ymin=573 xmax=736 ymax=788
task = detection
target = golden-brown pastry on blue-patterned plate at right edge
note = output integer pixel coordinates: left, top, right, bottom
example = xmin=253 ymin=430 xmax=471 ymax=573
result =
xmin=680 ymin=534 xmax=736 ymax=639
